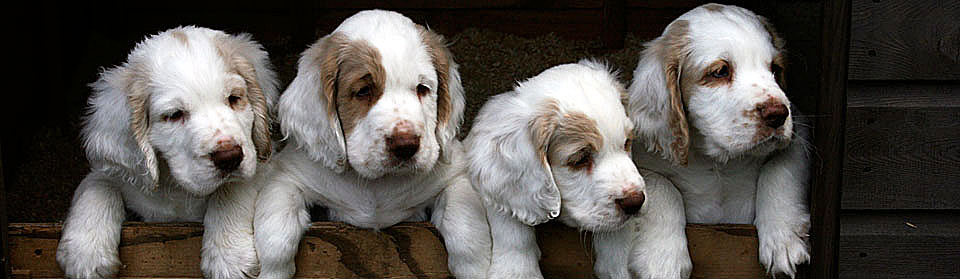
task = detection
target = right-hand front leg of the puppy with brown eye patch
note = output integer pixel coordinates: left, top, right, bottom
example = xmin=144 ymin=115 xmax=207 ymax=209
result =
xmin=432 ymin=175 xmax=491 ymax=279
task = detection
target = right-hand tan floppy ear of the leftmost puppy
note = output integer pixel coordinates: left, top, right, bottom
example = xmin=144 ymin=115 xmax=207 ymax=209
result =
xmin=217 ymin=34 xmax=277 ymax=162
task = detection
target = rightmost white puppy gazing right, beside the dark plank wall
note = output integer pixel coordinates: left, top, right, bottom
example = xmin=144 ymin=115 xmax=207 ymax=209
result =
xmin=628 ymin=4 xmax=810 ymax=277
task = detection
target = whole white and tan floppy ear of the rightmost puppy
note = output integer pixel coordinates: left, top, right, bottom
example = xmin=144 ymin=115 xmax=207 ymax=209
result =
xmin=627 ymin=20 xmax=690 ymax=165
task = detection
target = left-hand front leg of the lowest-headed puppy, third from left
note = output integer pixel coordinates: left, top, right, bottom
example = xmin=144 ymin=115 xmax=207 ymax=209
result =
xmin=487 ymin=207 xmax=543 ymax=279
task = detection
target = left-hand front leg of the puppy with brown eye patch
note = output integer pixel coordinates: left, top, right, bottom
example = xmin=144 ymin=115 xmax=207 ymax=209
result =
xmin=253 ymin=173 xmax=310 ymax=279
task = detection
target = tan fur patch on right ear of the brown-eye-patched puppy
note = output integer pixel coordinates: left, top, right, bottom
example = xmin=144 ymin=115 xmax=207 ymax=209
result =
xmin=417 ymin=25 xmax=456 ymax=127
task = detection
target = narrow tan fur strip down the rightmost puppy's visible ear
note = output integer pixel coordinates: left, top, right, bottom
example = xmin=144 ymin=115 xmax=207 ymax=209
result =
xmin=662 ymin=21 xmax=690 ymax=168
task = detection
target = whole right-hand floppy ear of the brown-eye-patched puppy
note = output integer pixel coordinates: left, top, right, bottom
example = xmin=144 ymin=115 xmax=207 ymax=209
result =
xmin=417 ymin=25 xmax=464 ymax=159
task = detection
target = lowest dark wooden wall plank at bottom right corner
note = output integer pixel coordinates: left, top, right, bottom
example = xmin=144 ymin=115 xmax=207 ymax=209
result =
xmin=839 ymin=211 xmax=960 ymax=279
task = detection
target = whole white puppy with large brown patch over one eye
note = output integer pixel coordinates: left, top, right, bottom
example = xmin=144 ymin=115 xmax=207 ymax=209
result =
xmin=255 ymin=10 xmax=489 ymax=278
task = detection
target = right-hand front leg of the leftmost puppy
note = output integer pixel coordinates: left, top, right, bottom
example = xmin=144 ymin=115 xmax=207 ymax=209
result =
xmin=200 ymin=180 xmax=260 ymax=278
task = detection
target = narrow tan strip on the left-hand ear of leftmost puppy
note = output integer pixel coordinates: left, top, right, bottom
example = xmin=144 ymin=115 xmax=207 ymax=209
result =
xmin=122 ymin=65 xmax=160 ymax=191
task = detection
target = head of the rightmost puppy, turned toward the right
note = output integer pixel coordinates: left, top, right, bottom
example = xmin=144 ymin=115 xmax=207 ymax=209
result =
xmin=628 ymin=4 xmax=793 ymax=164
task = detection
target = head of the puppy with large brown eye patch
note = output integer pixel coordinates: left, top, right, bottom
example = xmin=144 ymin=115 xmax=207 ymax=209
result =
xmin=279 ymin=10 xmax=464 ymax=179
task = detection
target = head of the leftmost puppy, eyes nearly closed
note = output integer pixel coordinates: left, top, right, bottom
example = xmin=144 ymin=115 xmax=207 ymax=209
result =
xmin=83 ymin=27 xmax=277 ymax=196
